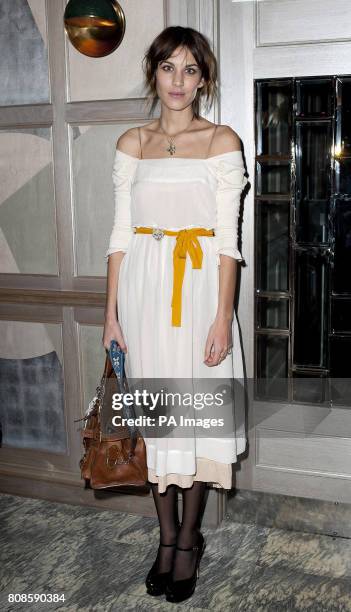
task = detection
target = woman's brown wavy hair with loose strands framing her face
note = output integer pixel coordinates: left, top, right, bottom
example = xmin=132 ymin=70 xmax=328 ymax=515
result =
xmin=142 ymin=26 xmax=218 ymax=119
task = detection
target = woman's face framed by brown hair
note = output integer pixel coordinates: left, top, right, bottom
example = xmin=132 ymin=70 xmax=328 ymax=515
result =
xmin=156 ymin=47 xmax=204 ymax=110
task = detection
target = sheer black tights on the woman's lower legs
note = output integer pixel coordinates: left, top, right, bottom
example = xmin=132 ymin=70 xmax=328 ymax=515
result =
xmin=151 ymin=481 xmax=206 ymax=580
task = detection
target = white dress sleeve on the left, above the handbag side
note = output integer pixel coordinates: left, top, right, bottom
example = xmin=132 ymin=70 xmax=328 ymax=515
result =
xmin=105 ymin=149 xmax=138 ymax=259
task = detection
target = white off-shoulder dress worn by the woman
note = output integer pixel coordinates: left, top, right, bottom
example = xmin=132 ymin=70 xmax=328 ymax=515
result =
xmin=105 ymin=149 xmax=247 ymax=493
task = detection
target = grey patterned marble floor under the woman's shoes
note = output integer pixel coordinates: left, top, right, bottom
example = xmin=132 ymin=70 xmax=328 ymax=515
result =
xmin=0 ymin=494 xmax=351 ymax=612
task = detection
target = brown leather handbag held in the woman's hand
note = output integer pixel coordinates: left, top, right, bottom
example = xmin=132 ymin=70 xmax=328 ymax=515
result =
xmin=75 ymin=340 xmax=148 ymax=489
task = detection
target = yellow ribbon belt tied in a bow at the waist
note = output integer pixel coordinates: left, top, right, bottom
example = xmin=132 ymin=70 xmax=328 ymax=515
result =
xmin=134 ymin=227 xmax=214 ymax=327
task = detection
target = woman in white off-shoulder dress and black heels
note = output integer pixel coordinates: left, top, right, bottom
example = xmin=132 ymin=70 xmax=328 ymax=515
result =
xmin=103 ymin=26 xmax=247 ymax=602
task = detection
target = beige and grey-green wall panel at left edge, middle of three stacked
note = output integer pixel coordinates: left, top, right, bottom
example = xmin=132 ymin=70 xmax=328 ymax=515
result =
xmin=0 ymin=127 xmax=58 ymax=274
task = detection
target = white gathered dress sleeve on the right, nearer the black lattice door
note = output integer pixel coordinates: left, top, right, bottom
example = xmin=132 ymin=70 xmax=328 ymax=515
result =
xmin=215 ymin=151 xmax=248 ymax=265
